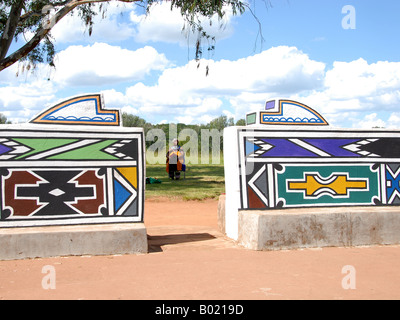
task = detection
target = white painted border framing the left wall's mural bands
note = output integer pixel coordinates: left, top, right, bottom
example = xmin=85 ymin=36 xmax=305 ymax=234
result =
xmin=0 ymin=123 xmax=146 ymax=228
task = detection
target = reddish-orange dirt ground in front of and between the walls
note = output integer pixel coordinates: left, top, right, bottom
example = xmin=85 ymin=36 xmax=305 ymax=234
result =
xmin=0 ymin=199 xmax=400 ymax=300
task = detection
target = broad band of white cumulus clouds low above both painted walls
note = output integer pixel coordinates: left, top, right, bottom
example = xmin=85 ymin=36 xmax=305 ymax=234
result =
xmin=0 ymin=43 xmax=400 ymax=128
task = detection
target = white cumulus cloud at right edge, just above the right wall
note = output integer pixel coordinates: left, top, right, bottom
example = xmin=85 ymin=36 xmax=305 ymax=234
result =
xmin=295 ymin=58 xmax=400 ymax=128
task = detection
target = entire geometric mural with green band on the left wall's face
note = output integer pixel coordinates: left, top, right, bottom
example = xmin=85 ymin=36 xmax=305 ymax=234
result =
xmin=0 ymin=129 xmax=144 ymax=226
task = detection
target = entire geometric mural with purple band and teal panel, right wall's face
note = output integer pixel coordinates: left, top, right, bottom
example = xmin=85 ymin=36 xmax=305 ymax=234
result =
xmin=239 ymin=129 xmax=400 ymax=209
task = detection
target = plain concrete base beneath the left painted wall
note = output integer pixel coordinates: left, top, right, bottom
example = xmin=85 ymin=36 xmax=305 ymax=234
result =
xmin=0 ymin=223 xmax=148 ymax=260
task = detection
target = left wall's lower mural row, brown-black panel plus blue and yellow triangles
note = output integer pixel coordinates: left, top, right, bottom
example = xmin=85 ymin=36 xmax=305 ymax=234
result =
xmin=0 ymin=167 xmax=138 ymax=220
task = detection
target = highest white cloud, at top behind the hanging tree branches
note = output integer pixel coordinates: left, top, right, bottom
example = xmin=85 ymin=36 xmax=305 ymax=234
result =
xmin=51 ymin=1 xmax=233 ymax=46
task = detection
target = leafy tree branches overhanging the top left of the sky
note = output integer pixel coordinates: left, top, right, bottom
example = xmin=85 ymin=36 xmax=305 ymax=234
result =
xmin=0 ymin=0 xmax=250 ymax=71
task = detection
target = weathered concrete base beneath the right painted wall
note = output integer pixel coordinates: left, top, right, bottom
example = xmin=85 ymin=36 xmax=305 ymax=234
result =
xmin=238 ymin=207 xmax=400 ymax=250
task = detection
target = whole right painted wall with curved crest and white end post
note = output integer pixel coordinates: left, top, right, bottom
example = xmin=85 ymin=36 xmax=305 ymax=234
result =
xmin=224 ymin=100 xmax=400 ymax=239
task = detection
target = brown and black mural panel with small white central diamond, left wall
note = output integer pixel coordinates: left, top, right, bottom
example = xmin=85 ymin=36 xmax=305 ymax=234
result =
xmin=1 ymin=169 xmax=106 ymax=218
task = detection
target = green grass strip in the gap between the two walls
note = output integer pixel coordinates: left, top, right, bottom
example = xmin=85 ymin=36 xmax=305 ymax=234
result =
xmin=146 ymin=164 xmax=225 ymax=200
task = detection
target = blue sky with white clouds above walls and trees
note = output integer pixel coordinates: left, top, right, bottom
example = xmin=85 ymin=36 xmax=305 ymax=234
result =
xmin=0 ymin=0 xmax=400 ymax=128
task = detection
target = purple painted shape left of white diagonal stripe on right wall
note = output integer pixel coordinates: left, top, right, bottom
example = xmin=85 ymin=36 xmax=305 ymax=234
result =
xmin=262 ymin=139 xmax=319 ymax=157
